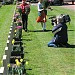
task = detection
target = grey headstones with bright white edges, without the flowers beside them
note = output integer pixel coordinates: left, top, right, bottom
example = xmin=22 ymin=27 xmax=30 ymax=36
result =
xmin=0 ymin=20 xmax=15 ymax=75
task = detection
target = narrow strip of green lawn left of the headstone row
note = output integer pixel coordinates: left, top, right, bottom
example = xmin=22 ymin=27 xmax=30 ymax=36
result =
xmin=0 ymin=5 xmax=15 ymax=65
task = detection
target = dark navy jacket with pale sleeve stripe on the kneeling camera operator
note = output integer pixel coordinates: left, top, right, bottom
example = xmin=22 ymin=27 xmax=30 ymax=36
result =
xmin=52 ymin=23 xmax=68 ymax=44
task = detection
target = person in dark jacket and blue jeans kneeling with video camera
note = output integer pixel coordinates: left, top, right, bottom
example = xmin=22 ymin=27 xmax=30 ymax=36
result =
xmin=48 ymin=15 xmax=69 ymax=47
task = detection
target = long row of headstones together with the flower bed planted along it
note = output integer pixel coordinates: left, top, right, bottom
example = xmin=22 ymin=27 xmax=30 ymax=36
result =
xmin=0 ymin=2 xmax=26 ymax=75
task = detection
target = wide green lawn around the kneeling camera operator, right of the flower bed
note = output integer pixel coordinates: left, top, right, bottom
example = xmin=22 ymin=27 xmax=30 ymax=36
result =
xmin=23 ymin=6 xmax=75 ymax=75
